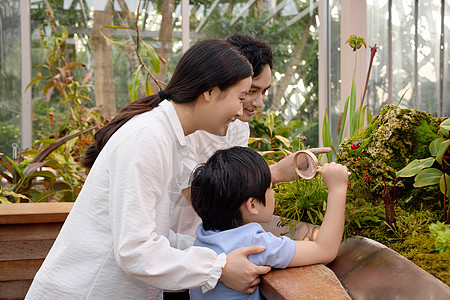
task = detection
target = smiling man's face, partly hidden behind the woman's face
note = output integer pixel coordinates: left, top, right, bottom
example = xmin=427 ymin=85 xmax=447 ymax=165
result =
xmin=239 ymin=65 xmax=272 ymax=122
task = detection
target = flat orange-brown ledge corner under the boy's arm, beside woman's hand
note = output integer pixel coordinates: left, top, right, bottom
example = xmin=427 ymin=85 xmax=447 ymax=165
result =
xmin=261 ymin=265 xmax=351 ymax=300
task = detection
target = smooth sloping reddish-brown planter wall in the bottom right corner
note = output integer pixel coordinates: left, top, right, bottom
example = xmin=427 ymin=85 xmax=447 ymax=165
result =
xmin=328 ymin=237 xmax=450 ymax=300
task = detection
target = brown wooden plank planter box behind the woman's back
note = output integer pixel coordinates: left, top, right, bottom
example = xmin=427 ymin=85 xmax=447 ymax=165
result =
xmin=0 ymin=202 xmax=73 ymax=299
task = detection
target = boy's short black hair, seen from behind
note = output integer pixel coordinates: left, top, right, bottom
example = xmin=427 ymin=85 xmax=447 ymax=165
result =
xmin=191 ymin=146 xmax=272 ymax=230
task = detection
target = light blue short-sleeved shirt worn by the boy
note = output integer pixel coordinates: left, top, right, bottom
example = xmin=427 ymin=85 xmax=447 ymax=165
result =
xmin=189 ymin=223 xmax=295 ymax=300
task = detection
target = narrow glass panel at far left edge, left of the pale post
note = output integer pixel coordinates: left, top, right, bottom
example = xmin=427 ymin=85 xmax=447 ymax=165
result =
xmin=0 ymin=0 xmax=22 ymax=158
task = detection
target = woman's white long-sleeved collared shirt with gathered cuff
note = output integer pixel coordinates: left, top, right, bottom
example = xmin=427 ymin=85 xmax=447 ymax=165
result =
xmin=26 ymin=101 xmax=226 ymax=300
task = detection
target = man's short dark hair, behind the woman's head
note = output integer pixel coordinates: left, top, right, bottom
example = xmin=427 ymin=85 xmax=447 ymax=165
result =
xmin=227 ymin=33 xmax=273 ymax=77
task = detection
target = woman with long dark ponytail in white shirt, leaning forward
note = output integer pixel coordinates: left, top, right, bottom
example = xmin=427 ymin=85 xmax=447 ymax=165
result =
xmin=26 ymin=40 xmax=270 ymax=299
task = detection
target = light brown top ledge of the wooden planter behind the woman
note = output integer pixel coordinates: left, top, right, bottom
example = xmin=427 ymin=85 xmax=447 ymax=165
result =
xmin=0 ymin=202 xmax=73 ymax=224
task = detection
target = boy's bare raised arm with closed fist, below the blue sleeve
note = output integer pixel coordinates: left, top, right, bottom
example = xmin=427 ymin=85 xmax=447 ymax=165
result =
xmin=289 ymin=163 xmax=348 ymax=267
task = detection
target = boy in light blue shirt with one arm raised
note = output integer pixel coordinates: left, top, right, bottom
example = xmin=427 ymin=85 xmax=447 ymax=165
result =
xmin=190 ymin=146 xmax=348 ymax=300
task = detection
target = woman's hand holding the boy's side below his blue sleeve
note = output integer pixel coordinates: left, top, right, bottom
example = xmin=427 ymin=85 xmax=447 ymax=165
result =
xmin=220 ymin=245 xmax=271 ymax=294
